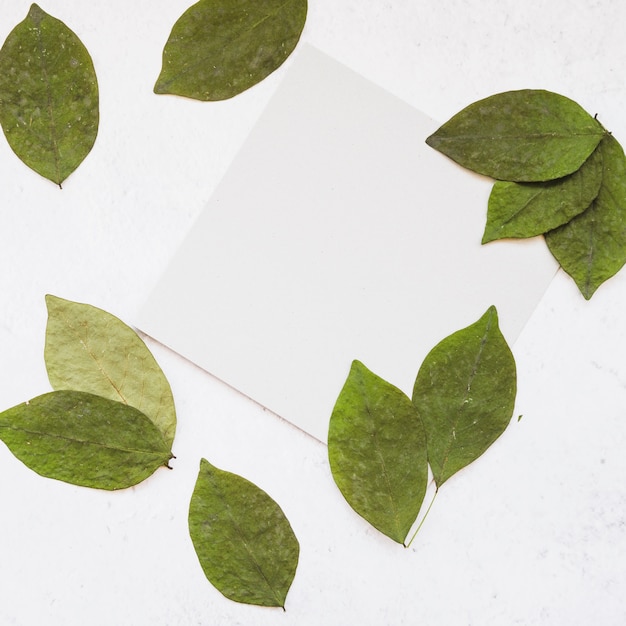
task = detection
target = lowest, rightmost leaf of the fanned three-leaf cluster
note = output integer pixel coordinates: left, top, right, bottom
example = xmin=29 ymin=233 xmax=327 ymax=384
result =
xmin=545 ymin=135 xmax=626 ymax=300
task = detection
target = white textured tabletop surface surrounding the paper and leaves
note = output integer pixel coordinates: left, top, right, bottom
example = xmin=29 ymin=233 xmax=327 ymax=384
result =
xmin=0 ymin=0 xmax=626 ymax=626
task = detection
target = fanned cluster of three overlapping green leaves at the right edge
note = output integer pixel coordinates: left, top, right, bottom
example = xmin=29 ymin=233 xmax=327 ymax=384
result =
xmin=426 ymin=89 xmax=626 ymax=299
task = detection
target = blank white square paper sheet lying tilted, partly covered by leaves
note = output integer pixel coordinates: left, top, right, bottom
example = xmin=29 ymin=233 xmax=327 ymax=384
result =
xmin=137 ymin=44 xmax=557 ymax=441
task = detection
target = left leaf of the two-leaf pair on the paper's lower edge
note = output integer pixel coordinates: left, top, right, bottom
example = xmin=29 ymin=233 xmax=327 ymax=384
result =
xmin=328 ymin=361 xmax=428 ymax=543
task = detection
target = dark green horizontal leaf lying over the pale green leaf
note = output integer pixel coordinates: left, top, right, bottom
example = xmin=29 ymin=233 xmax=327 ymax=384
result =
xmin=0 ymin=391 xmax=172 ymax=489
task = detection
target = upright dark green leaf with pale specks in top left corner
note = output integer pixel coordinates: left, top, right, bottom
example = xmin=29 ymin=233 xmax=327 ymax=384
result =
xmin=0 ymin=4 xmax=99 ymax=185
